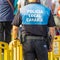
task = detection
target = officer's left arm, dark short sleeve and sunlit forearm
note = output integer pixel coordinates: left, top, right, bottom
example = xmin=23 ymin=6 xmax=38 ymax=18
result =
xmin=12 ymin=11 xmax=22 ymax=40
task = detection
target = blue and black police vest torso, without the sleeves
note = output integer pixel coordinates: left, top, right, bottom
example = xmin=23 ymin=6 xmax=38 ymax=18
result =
xmin=20 ymin=4 xmax=50 ymax=36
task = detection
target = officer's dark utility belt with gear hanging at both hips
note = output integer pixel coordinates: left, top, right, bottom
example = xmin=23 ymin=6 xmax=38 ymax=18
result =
xmin=21 ymin=34 xmax=51 ymax=49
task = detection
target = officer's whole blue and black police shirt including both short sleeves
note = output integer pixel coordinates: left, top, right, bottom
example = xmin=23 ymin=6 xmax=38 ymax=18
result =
xmin=12 ymin=3 xmax=55 ymax=36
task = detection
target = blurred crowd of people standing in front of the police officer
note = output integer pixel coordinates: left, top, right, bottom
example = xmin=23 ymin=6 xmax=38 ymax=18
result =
xmin=0 ymin=0 xmax=60 ymax=43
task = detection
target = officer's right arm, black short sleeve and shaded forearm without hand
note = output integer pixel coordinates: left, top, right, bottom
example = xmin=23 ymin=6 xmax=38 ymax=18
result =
xmin=48 ymin=13 xmax=56 ymax=40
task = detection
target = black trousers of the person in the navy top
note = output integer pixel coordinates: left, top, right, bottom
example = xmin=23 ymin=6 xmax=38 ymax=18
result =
xmin=0 ymin=21 xmax=12 ymax=43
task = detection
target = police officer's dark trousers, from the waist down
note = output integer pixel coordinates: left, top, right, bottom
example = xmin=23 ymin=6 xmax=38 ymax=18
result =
xmin=23 ymin=36 xmax=48 ymax=60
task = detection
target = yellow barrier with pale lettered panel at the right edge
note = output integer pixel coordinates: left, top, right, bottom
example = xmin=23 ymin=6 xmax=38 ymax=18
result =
xmin=53 ymin=35 xmax=60 ymax=60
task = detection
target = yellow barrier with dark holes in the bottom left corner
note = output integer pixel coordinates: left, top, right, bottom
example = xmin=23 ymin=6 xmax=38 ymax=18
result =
xmin=0 ymin=42 xmax=9 ymax=60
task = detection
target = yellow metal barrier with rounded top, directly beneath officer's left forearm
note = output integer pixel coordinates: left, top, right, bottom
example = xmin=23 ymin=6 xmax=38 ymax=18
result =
xmin=9 ymin=40 xmax=23 ymax=60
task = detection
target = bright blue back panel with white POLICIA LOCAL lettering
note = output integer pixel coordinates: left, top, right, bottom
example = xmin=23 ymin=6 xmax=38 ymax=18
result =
xmin=20 ymin=4 xmax=50 ymax=25
